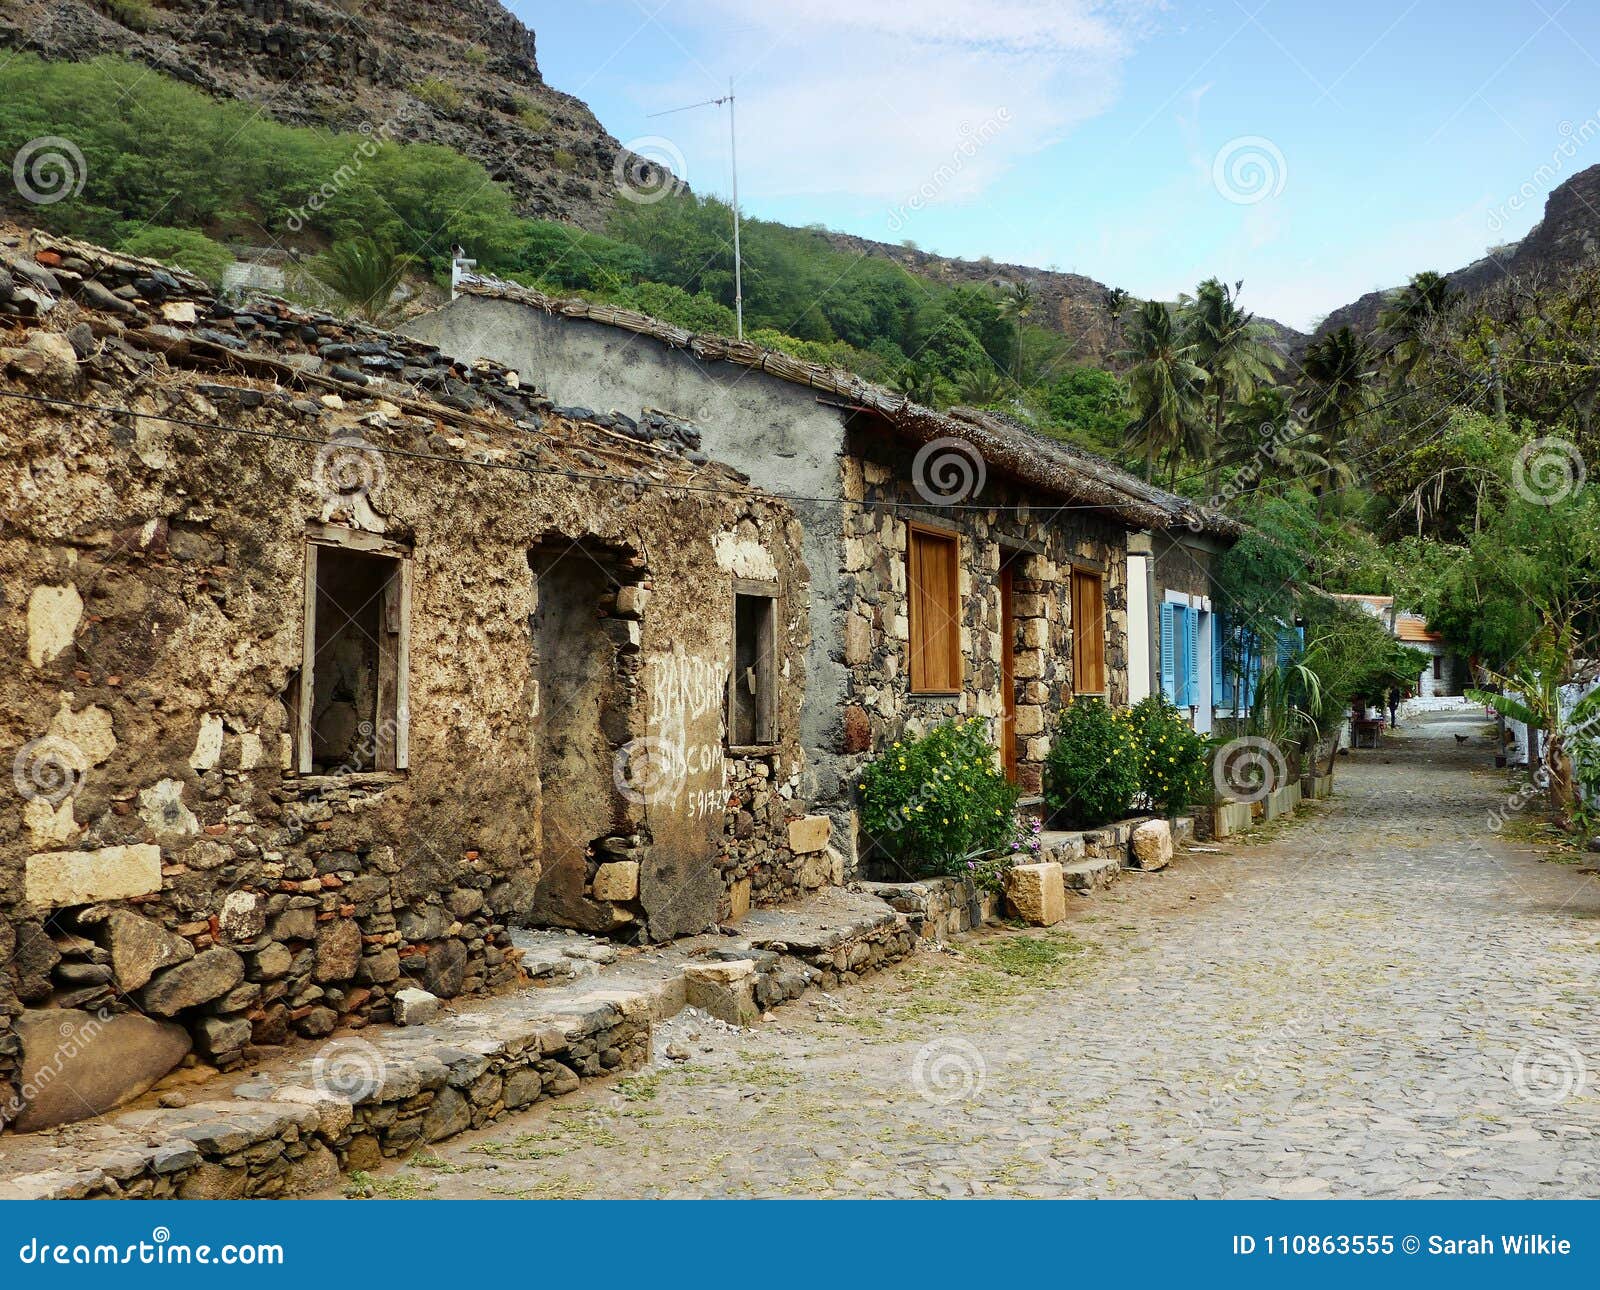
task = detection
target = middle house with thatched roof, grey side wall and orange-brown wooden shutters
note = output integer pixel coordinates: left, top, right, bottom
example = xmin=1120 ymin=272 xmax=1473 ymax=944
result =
xmin=406 ymin=274 xmax=1237 ymax=874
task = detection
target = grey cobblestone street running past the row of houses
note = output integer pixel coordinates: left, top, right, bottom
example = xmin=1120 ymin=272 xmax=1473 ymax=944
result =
xmin=347 ymin=719 xmax=1600 ymax=1197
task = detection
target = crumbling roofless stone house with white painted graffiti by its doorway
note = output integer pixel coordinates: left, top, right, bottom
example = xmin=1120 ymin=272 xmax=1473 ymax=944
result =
xmin=0 ymin=235 xmax=812 ymax=1125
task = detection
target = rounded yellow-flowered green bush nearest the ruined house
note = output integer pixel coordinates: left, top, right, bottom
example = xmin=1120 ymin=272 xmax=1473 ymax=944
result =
xmin=856 ymin=719 xmax=1018 ymax=874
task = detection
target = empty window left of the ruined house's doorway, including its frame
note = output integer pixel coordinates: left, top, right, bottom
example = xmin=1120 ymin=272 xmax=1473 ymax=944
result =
xmin=294 ymin=528 xmax=411 ymax=775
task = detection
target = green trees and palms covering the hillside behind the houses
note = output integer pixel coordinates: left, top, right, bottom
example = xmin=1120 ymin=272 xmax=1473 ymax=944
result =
xmin=0 ymin=54 xmax=1600 ymax=691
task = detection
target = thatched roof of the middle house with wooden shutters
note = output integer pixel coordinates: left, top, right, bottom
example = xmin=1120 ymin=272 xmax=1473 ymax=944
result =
xmin=459 ymin=274 xmax=1245 ymax=541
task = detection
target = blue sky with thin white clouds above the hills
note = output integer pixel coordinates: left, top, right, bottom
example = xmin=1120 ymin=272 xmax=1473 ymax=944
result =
xmin=510 ymin=0 xmax=1600 ymax=328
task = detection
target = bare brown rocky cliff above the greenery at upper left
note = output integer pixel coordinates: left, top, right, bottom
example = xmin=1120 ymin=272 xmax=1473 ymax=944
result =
xmin=0 ymin=0 xmax=656 ymax=227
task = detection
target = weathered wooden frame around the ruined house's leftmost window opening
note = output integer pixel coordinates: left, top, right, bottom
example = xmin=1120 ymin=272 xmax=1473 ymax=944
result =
xmin=293 ymin=523 xmax=413 ymax=775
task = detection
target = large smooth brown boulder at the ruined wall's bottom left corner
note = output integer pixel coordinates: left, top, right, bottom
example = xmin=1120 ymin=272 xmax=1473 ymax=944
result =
xmin=10 ymin=1008 xmax=189 ymax=1133
